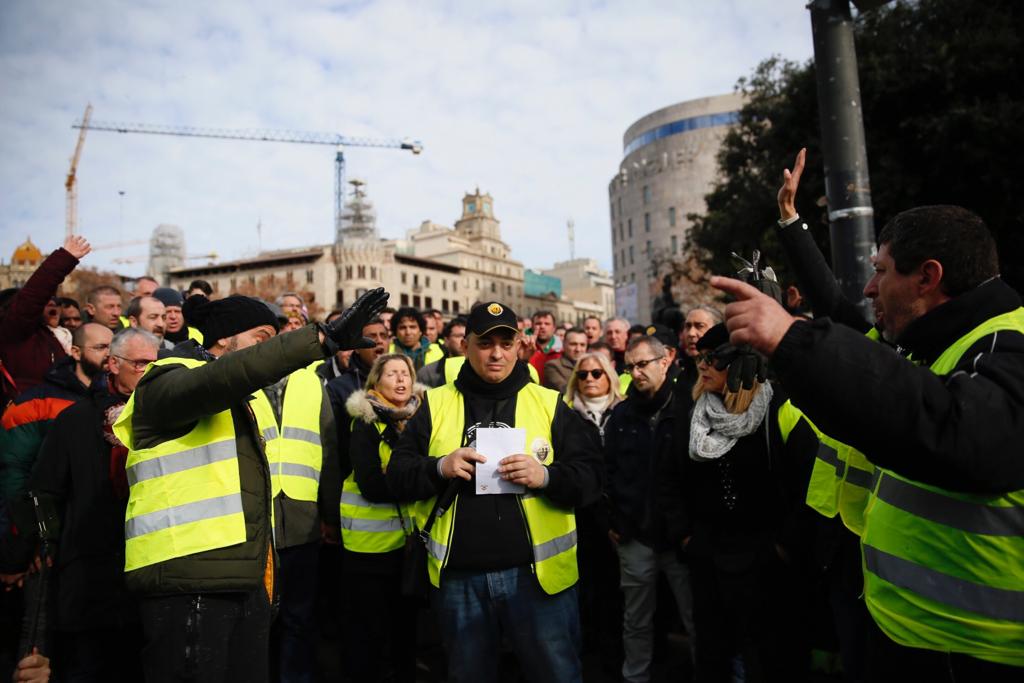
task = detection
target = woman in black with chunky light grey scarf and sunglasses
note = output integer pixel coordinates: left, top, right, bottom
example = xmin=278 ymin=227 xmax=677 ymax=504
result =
xmin=676 ymin=324 xmax=817 ymax=683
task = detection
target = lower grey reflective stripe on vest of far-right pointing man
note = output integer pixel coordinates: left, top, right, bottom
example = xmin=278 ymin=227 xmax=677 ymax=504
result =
xmin=863 ymin=544 xmax=1024 ymax=622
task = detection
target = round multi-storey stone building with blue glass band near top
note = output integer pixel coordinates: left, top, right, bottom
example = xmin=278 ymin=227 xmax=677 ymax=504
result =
xmin=608 ymin=94 xmax=743 ymax=323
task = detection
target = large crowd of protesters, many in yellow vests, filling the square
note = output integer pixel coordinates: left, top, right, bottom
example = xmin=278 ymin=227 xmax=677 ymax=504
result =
xmin=0 ymin=153 xmax=1024 ymax=683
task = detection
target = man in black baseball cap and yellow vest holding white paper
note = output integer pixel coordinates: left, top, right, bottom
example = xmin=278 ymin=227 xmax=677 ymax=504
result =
xmin=387 ymin=301 xmax=601 ymax=683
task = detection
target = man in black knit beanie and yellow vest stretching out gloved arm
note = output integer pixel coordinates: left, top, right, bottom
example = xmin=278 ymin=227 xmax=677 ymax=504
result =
xmin=114 ymin=289 xmax=387 ymax=682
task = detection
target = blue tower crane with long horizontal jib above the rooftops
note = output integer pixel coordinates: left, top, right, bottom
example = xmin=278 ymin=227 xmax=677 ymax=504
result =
xmin=72 ymin=117 xmax=423 ymax=231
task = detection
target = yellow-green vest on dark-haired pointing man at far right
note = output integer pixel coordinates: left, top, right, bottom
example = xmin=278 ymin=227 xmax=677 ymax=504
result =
xmin=861 ymin=308 xmax=1024 ymax=663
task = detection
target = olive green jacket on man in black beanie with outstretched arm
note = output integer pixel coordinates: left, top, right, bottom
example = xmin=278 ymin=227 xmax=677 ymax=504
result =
xmin=125 ymin=326 xmax=326 ymax=595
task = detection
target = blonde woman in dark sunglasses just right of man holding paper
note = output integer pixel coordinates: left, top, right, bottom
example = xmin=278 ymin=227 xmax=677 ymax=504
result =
xmin=565 ymin=351 xmax=623 ymax=675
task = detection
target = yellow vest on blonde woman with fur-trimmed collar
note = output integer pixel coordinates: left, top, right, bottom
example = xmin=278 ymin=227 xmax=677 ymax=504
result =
xmin=341 ymin=422 xmax=413 ymax=553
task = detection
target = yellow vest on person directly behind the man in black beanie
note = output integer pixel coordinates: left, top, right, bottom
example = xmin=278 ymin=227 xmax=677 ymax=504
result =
xmin=266 ymin=368 xmax=324 ymax=503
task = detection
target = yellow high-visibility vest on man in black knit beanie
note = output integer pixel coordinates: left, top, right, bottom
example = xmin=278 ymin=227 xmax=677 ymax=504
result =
xmin=114 ymin=358 xmax=278 ymax=571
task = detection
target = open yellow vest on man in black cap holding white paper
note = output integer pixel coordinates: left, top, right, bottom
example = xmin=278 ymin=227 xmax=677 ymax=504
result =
xmin=417 ymin=383 xmax=580 ymax=595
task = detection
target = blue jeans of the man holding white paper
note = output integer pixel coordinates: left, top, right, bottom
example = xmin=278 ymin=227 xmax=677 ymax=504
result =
xmin=432 ymin=567 xmax=583 ymax=683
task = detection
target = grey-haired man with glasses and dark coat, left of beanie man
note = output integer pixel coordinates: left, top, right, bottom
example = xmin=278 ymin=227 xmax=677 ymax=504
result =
xmin=25 ymin=326 xmax=160 ymax=681
